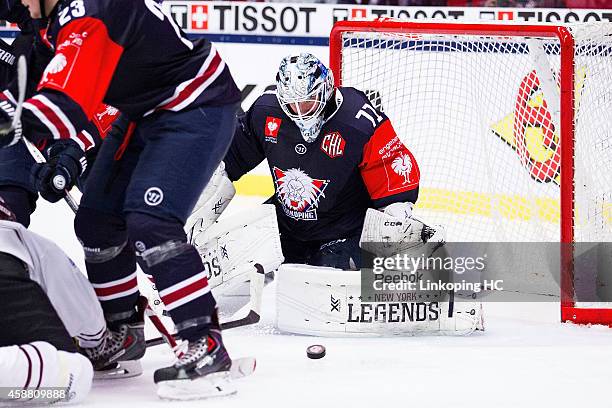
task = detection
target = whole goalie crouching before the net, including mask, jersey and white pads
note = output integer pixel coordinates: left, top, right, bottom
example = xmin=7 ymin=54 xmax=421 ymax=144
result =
xmin=224 ymin=53 xmax=482 ymax=335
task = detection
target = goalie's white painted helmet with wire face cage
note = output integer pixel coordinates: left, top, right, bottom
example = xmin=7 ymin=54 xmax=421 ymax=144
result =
xmin=276 ymin=53 xmax=334 ymax=143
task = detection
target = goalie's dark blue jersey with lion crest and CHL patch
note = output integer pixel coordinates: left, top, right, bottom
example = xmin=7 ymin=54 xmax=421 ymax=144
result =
xmin=224 ymin=88 xmax=420 ymax=241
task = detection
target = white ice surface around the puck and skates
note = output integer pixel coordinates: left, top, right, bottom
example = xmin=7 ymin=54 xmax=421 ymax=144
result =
xmin=32 ymin=197 xmax=612 ymax=408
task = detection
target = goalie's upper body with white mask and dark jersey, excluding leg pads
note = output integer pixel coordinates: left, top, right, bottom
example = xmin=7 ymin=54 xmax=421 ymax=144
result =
xmin=224 ymin=54 xmax=419 ymax=269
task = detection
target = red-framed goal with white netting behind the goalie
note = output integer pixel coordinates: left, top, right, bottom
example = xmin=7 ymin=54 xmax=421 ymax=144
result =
xmin=330 ymin=19 xmax=612 ymax=325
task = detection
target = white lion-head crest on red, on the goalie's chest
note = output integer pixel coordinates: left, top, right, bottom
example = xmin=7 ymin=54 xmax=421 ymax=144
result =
xmin=273 ymin=167 xmax=329 ymax=221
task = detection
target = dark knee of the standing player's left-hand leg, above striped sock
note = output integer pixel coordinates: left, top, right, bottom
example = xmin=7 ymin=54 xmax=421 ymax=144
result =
xmin=74 ymin=207 xmax=128 ymax=264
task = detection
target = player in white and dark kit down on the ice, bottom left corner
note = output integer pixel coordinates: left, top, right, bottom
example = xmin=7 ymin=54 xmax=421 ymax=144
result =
xmin=0 ymin=197 xmax=106 ymax=403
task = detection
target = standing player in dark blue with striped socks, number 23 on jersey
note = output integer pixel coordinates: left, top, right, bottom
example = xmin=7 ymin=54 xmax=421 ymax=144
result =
xmin=0 ymin=0 xmax=240 ymax=398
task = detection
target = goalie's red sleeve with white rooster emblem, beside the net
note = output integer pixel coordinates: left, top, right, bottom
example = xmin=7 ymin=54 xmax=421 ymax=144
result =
xmin=359 ymin=119 xmax=420 ymax=208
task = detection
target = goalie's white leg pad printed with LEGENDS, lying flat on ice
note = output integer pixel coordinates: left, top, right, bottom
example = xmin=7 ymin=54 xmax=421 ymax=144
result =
xmin=276 ymin=264 xmax=481 ymax=336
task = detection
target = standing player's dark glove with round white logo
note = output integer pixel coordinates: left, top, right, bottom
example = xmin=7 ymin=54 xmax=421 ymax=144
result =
xmin=32 ymin=139 xmax=87 ymax=203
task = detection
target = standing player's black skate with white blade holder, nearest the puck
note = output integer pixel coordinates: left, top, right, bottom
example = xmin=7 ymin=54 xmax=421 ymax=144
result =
xmin=153 ymin=329 xmax=236 ymax=400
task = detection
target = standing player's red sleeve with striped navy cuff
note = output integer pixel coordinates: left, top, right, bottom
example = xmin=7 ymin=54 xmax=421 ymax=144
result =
xmin=22 ymin=17 xmax=123 ymax=145
